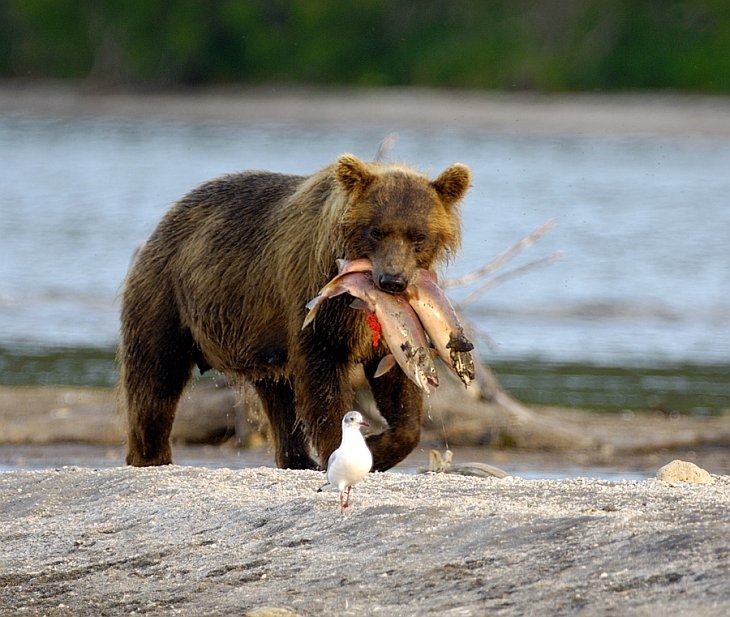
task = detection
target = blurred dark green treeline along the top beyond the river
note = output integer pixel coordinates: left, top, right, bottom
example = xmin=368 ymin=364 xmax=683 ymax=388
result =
xmin=0 ymin=0 xmax=730 ymax=92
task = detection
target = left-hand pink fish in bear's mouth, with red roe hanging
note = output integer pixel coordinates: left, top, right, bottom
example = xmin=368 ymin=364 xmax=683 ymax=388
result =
xmin=302 ymin=270 xmax=438 ymax=394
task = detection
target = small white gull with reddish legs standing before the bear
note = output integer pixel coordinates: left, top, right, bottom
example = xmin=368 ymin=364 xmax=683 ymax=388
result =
xmin=319 ymin=411 xmax=373 ymax=512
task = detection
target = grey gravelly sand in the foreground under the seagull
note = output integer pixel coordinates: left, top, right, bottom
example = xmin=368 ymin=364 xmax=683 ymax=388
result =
xmin=0 ymin=467 xmax=730 ymax=617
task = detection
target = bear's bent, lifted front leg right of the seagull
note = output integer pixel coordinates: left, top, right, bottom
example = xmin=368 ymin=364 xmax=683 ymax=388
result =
xmin=364 ymin=358 xmax=423 ymax=471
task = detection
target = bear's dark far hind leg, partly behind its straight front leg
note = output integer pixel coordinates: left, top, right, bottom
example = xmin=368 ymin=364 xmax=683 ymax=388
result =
xmin=255 ymin=379 xmax=317 ymax=469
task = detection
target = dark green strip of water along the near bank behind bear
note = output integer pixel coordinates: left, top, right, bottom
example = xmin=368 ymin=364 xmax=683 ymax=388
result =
xmin=0 ymin=345 xmax=730 ymax=415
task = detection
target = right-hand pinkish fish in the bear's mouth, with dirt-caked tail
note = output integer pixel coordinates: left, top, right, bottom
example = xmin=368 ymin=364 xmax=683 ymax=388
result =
xmin=404 ymin=270 xmax=475 ymax=386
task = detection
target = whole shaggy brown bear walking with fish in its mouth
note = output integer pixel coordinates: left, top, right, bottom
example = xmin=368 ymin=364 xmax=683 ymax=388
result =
xmin=120 ymin=154 xmax=471 ymax=471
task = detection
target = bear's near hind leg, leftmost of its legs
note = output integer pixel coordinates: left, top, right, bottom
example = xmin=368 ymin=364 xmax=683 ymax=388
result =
xmin=121 ymin=316 xmax=193 ymax=467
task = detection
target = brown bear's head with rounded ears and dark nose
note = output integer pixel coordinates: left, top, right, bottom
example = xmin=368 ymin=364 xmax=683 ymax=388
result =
xmin=335 ymin=154 xmax=471 ymax=293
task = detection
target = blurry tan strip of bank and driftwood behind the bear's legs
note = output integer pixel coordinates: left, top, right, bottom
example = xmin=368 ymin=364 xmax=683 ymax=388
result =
xmin=0 ymin=380 xmax=730 ymax=463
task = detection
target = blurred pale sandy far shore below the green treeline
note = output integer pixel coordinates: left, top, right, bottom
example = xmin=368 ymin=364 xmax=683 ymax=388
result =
xmin=0 ymin=81 xmax=730 ymax=137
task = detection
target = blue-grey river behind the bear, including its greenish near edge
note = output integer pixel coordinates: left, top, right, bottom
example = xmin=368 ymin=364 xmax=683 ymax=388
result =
xmin=0 ymin=113 xmax=730 ymax=410
